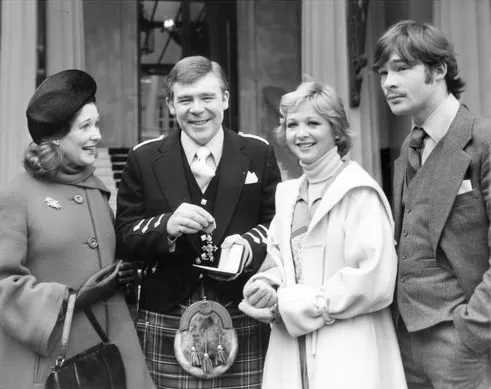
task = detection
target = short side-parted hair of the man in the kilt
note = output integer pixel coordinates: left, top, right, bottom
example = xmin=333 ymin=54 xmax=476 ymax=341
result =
xmin=166 ymin=55 xmax=229 ymax=100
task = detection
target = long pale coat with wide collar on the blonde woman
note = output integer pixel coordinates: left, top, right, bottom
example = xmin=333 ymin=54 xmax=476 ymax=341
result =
xmin=250 ymin=162 xmax=406 ymax=389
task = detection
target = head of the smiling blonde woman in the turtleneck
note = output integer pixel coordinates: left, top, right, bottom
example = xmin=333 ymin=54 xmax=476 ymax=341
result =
xmin=277 ymin=81 xmax=351 ymax=165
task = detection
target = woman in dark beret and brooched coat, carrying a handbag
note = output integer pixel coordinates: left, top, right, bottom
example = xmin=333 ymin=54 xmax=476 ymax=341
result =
xmin=0 ymin=70 xmax=155 ymax=389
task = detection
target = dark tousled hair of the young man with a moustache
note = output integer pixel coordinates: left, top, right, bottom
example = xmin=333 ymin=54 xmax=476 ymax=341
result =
xmin=372 ymin=20 xmax=465 ymax=98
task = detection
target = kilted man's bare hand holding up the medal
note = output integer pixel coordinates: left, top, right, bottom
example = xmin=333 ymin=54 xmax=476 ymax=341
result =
xmin=167 ymin=203 xmax=216 ymax=238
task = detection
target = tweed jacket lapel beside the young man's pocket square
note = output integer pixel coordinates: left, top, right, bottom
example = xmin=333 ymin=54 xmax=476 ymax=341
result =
xmin=430 ymin=105 xmax=474 ymax=252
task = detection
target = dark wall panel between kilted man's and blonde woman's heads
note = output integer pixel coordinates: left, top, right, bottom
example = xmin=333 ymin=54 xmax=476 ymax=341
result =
xmin=237 ymin=0 xmax=301 ymax=178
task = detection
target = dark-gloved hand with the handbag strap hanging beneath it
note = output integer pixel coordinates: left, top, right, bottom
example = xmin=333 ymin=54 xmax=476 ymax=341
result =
xmin=75 ymin=261 xmax=122 ymax=309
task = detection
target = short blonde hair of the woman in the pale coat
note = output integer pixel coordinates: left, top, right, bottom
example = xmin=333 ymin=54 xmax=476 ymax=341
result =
xmin=276 ymin=81 xmax=352 ymax=157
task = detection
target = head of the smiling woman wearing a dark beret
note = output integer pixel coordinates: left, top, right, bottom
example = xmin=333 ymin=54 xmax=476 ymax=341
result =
xmin=24 ymin=69 xmax=101 ymax=177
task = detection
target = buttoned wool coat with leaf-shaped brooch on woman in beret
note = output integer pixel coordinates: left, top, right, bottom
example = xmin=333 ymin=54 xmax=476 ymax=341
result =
xmin=0 ymin=173 xmax=155 ymax=389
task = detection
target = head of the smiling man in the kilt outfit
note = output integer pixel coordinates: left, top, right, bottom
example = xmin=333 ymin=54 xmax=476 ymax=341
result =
xmin=166 ymin=56 xmax=229 ymax=145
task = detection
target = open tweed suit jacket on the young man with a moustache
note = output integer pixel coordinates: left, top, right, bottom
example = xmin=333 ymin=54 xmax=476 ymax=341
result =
xmin=394 ymin=105 xmax=491 ymax=354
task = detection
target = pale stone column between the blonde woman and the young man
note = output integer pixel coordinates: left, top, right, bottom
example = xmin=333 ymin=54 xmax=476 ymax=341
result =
xmin=302 ymin=0 xmax=381 ymax=182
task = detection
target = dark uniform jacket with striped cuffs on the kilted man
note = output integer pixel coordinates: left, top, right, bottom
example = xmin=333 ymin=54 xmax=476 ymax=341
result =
xmin=116 ymin=130 xmax=281 ymax=313
